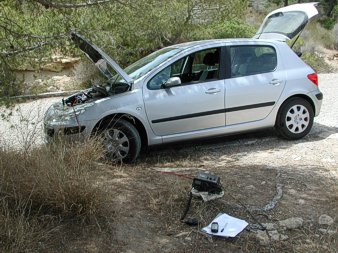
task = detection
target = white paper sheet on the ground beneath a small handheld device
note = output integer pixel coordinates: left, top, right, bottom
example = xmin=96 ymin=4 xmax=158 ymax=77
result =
xmin=202 ymin=213 xmax=248 ymax=237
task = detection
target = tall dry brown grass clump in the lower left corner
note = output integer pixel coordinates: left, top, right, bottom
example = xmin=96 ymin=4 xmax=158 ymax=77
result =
xmin=0 ymin=141 xmax=108 ymax=252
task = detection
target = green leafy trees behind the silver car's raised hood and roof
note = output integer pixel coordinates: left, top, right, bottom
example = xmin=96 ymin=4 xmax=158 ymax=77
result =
xmin=0 ymin=0 xmax=252 ymax=96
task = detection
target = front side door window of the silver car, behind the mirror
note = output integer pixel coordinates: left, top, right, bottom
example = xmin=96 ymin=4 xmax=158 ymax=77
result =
xmin=148 ymin=48 xmax=220 ymax=90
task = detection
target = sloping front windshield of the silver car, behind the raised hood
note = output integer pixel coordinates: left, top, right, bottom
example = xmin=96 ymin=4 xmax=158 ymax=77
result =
xmin=124 ymin=48 xmax=183 ymax=80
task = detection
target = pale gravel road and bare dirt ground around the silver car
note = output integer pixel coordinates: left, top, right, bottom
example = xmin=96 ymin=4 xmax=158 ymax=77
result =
xmin=0 ymin=74 xmax=338 ymax=252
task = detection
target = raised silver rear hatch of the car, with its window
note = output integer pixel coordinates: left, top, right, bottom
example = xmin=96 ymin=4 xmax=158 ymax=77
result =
xmin=254 ymin=2 xmax=318 ymax=42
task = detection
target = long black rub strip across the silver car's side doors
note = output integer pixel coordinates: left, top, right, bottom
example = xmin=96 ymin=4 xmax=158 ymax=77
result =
xmin=151 ymin=102 xmax=275 ymax=124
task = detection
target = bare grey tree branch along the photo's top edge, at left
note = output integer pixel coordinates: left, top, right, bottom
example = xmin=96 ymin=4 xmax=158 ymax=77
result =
xmin=35 ymin=0 xmax=126 ymax=9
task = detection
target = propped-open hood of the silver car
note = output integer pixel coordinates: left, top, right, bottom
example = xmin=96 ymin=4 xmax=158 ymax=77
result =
xmin=71 ymin=32 xmax=133 ymax=84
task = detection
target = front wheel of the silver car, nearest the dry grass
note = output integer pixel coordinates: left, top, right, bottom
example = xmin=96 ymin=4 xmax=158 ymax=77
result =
xmin=101 ymin=119 xmax=141 ymax=163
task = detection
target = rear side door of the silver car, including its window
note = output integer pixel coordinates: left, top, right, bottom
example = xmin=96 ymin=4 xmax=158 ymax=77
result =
xmin=225 ymin=43 xmax=286 ymax=125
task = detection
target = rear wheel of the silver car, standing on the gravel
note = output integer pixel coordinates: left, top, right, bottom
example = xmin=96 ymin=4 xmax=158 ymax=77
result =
xmin=275 ymin=97 xmax=314 ymax=140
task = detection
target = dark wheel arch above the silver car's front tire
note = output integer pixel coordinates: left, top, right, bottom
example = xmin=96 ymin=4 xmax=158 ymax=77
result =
xmin=91 ymin=113 xmax=148 ymax=147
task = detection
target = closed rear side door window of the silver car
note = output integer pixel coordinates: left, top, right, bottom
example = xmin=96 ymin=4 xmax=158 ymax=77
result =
xmin=230 ymin=45 xmax=277 ymax=77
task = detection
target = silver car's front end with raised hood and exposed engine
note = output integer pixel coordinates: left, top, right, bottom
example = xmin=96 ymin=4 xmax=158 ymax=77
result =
xmin=44 ymin=32 xmax=133 ymax=142
